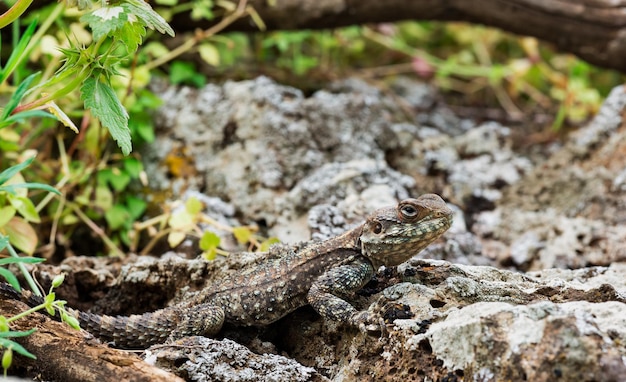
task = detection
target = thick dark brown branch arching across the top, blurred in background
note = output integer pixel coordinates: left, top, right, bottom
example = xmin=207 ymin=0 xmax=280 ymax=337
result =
xmin=177 ymin=0 xmax=626 ymax=72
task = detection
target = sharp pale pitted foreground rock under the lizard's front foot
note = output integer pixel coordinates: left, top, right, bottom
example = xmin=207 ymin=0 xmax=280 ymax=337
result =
xmin=286 ymin=259 xmax=626 ymax=381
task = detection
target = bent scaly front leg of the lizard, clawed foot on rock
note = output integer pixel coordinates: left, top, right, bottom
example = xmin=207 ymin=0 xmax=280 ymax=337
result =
xmin=307 ymin=258 xmax=374 ymax=323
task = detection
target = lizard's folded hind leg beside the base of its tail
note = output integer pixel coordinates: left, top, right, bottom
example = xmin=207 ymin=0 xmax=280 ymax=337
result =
xmin=167 ymin=303 xmax=224 ymax=342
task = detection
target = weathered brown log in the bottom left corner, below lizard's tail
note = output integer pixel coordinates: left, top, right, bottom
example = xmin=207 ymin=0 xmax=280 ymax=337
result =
xmin=0 ymin=300 xmax=183 ymax=382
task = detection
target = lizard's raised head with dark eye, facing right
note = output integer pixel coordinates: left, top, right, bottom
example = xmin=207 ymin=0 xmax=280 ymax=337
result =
xmin=359 ymin=194 xmax=453 ymax=268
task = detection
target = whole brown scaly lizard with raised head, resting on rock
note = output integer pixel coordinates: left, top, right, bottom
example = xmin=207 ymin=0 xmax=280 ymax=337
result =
xmin=0 ymin=194 xmax=453 ymax=349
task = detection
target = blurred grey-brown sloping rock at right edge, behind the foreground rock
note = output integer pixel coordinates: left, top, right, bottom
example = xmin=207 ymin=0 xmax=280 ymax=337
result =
xmin=472 ymin=86 xmax=626 ymax=270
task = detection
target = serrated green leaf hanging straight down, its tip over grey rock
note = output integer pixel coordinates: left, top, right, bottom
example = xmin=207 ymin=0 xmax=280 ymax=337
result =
xmin=80 ymin=77 xmax=132 ymax=155
